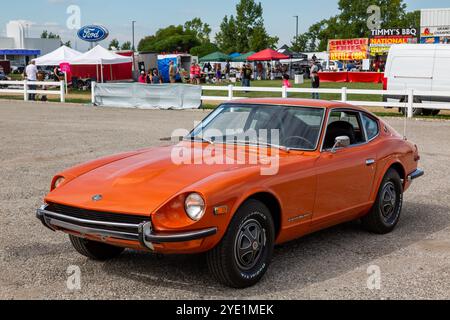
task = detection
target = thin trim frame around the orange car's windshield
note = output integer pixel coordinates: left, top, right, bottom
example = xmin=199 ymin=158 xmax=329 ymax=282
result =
xmin=185 ymin=102 xmax=327 ymax=152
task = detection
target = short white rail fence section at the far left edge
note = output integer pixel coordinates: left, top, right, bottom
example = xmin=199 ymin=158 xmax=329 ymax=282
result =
xmin=0 ymin=80 xmax=66 ymax=102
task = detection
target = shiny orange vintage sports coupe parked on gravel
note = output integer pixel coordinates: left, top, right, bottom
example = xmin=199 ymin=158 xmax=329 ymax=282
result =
xmin=37 ymin=99 xmax=424 ymax=288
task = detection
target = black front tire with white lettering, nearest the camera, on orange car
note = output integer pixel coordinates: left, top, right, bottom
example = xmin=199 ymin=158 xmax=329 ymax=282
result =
xmin=207 ymin=200 xmax=275 ymax=289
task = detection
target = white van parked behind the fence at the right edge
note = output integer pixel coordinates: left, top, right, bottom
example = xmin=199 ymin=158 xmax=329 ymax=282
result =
xmin=384 ymin=44 xmax=450 ymax=116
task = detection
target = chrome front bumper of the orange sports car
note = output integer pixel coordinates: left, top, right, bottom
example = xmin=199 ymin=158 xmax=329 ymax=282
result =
xmin=36 ymin=205 xmax=217 ymax=251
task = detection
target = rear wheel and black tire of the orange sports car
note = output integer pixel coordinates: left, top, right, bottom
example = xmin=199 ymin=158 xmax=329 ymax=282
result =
xmin=362 ymin=169 xmax=403 ymax=234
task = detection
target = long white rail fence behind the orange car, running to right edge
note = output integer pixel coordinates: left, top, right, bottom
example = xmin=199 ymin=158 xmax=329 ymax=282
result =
xmin=202 ymin=85 xmax=450 ymax=118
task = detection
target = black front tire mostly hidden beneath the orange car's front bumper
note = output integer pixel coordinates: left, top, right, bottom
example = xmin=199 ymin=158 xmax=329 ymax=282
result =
xmin=70 ymin=235 xmax=125 ymax=261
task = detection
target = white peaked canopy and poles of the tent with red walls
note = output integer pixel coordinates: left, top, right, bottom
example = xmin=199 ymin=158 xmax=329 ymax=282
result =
xmin=70 ymin=45 xmax=133 ymax=82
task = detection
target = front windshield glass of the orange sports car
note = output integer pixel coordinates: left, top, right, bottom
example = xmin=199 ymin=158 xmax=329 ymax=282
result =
xmin=187 ymin=104 xmax=325 ymax=151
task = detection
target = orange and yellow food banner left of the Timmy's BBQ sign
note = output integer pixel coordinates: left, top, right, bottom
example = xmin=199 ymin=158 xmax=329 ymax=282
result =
xmin=328 ymin=38 xmax=369 ymax=61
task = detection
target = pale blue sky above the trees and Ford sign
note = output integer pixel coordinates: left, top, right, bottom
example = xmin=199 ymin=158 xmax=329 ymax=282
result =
xmin=0 ymin=0 xmax=450 ymax=49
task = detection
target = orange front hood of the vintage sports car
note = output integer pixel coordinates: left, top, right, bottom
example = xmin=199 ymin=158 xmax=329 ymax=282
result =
xmin=46 ymin=143 xmax=278 ymax=215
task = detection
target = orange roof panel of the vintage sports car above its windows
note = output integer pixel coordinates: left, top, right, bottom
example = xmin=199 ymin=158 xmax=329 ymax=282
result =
xmin=227 ymin=98 xmax=363 ymax=110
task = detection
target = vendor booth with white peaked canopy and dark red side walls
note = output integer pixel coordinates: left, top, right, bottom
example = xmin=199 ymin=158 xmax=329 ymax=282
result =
xmin=70 ymin=45 xmax=133 ymax=82
